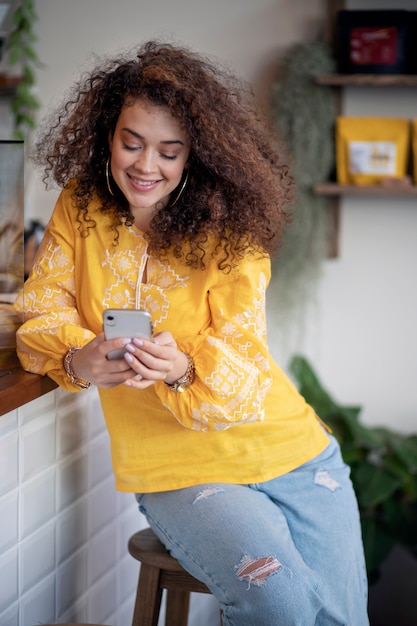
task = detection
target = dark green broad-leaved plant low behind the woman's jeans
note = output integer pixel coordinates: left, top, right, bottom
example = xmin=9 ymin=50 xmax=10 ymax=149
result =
xmin=290 ymin=355 xmax=417 ymax=584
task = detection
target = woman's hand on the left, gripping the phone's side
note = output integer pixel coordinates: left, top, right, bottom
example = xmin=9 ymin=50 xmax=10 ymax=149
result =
xmin=72 ymin=333 xmax=136 ymax=389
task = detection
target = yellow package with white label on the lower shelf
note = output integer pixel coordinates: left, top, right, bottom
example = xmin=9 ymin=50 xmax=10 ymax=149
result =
xmin=336 ymin=116 xmax=410 ymax=185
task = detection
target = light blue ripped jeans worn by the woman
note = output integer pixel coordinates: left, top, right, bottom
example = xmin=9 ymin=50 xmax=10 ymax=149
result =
xmin=136 ymin=437 xmax=369 ymax=626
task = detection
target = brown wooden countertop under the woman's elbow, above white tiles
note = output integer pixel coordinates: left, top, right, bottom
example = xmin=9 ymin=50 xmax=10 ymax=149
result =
xmin=0 ymin=367 xmax=57 ymax=415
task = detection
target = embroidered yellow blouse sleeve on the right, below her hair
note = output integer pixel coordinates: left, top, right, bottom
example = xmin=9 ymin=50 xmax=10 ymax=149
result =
xmin=156 ymin=252 xmax=272 ymax=430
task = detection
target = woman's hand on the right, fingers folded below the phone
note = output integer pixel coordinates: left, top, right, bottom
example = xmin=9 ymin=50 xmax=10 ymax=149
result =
xmin=124 ymin=331 xmax=188 ymax=389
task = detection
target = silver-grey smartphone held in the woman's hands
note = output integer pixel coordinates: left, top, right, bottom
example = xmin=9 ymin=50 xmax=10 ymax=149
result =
xmin=103 ymin=309 xmax=153 ymax=359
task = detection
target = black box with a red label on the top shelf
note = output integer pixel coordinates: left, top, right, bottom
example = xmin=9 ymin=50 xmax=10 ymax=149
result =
xmin=337 ymin=9 xmax=417 ymax=74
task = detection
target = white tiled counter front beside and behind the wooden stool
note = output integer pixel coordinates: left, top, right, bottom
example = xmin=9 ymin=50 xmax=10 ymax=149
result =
xmin=0 ymin=389 xmax=218 ymax=626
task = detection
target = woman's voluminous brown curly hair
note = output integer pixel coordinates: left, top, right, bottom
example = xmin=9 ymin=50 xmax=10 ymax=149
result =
xmin=32 ymin=41 xmax=293 ymax=270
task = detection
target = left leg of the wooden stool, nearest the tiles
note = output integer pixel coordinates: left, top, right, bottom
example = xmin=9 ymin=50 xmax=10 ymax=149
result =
xmin=132 ymin=563 xmax=162 ymax=626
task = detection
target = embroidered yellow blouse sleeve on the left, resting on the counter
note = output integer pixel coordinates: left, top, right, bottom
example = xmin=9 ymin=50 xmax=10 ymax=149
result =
xmin=15 ymin=190 xmax=95 ymax=391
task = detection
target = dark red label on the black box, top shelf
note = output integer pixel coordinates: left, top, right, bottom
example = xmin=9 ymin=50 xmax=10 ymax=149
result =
xmin=350 ymin=27 xmax=398 ymax=65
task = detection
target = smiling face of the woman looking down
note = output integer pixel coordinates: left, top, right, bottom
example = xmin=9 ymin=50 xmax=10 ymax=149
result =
xmin=109 ymin=100 xmax=190 ymax=230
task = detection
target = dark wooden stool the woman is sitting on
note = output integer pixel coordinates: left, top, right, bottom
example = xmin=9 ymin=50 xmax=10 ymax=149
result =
xmin=128 ymin=528 xmax=216 ymax=626
